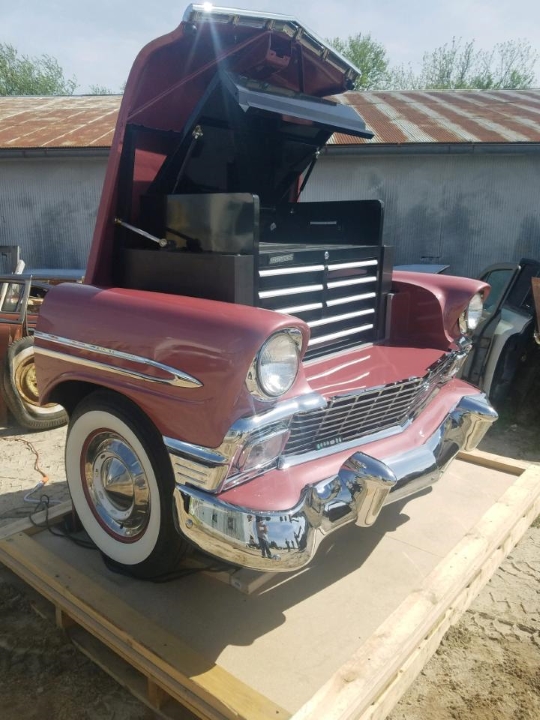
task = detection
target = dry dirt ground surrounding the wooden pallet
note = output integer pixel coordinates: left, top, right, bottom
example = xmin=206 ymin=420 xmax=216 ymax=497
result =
xmin=0 ymin=396 xmax=540 ymax=720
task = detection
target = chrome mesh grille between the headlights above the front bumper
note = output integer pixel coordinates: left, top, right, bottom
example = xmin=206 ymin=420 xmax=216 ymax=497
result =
xmin=284 ymin=354 xmax=455 ymax=455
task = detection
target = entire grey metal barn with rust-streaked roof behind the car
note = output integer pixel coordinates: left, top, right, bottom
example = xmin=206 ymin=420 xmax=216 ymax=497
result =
xmin=0 ymin=90 xmax=540 ymax=275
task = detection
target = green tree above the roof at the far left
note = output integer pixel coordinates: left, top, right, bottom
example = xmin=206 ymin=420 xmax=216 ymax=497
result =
xmin=0 ymin=43 xmax=77 ymax=95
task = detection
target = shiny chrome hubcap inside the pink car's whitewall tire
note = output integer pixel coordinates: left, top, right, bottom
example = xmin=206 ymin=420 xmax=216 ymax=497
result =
xmin=81 ymin=430 xmax=150 ymax=542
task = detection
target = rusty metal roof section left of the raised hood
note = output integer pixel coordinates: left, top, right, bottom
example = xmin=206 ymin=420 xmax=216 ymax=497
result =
xmin=0 ymin=95 xmax=121 ymax=149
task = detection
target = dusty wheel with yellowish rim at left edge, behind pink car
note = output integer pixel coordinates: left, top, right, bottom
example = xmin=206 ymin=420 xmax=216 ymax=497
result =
xmin=3 ymin=337 xmax=68 ymax=430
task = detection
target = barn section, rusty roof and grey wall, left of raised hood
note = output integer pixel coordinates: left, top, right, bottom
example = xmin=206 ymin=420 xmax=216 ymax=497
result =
xmin=0 ymin=96 xmax=116 ymax=271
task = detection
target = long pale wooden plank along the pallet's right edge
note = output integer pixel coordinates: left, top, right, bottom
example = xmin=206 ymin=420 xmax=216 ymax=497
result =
xmin=291 ymin=466 xmax=540 ymax=720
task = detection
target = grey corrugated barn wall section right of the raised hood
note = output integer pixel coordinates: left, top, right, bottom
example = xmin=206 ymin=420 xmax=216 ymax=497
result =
xmin=302 ymin=153 xmax=540 ymax=276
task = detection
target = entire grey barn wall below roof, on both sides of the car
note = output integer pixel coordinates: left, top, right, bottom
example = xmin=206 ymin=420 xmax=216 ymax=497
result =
xmin=0 ymin=153 xmax=540 ymax=276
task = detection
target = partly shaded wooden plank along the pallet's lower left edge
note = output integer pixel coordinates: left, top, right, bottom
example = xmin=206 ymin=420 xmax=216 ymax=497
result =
xmin=0 ymin=533 xmax=290 ymax=720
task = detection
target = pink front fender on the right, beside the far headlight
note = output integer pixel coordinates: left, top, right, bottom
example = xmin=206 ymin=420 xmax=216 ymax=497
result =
xmin=390 ymin=270 xmax=490 ymax=350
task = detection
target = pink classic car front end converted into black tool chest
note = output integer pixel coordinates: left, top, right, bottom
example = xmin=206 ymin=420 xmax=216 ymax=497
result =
xmin=35 ymin=5 xmax=496 ymax=577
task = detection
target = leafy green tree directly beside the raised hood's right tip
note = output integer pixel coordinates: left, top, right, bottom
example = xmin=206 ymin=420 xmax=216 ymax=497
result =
xmin=328 ymin=33 xmax=389 ymax=90
